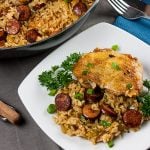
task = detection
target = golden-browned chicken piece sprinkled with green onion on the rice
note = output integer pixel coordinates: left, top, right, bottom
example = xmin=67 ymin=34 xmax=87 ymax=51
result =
xmin=73 ymin=48 xmax=143 ymax=97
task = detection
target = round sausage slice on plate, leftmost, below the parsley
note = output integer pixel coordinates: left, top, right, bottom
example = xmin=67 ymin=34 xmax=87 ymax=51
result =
xmin=55 ymin=93 xmax=71 ymax=111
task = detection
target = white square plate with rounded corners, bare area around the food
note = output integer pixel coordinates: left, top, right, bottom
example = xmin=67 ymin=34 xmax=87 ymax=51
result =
xmin=18 ymin=23 xmax=150 ymax=150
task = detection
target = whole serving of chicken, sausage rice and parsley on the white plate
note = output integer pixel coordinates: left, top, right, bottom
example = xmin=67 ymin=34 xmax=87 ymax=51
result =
xmin=39 ymin=45 xmax=150 ymax=147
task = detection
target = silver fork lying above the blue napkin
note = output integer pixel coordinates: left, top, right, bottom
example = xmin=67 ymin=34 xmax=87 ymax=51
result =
xmin=108 ymin=0 xmax=150 ymax=20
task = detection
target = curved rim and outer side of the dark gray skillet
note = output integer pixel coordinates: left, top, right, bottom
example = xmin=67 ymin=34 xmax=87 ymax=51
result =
xmin=0 ymin=0 xmax=99 ymax=59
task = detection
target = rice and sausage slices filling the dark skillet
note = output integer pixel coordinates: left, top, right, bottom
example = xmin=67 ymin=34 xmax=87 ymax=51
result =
xmin=0 ymin=0 xmax=94 ymax=47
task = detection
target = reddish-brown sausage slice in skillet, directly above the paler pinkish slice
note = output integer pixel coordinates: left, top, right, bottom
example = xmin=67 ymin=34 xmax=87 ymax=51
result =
xmin=17 ymin=5 xmax=31 ymax=21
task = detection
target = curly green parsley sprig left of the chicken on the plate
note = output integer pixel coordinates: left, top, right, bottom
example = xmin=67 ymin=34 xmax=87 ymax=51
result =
xmin=38 ymin=53 xmax=81 ymax=96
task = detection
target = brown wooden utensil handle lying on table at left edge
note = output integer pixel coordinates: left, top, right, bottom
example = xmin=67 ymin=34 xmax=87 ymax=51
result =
xmin=0 ymin=101 xmax=21 ymax=124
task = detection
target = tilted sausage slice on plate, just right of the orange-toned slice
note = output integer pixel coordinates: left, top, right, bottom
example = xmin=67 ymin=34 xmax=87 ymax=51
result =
xmin=101 ymin=104 xmax=116 ymax=117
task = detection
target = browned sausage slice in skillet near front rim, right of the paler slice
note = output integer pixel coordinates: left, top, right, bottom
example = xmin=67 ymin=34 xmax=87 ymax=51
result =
xmin=26 ymin=29 xmax=40 ymax=43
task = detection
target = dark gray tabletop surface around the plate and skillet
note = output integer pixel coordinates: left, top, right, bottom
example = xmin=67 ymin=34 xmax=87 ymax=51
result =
xmin=0 ymin=0 xmax=115 ymax=150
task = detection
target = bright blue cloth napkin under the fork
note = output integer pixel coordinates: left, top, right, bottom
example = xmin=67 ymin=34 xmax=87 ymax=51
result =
xmin=114 ymin=0 xmax=150 ymax=45
